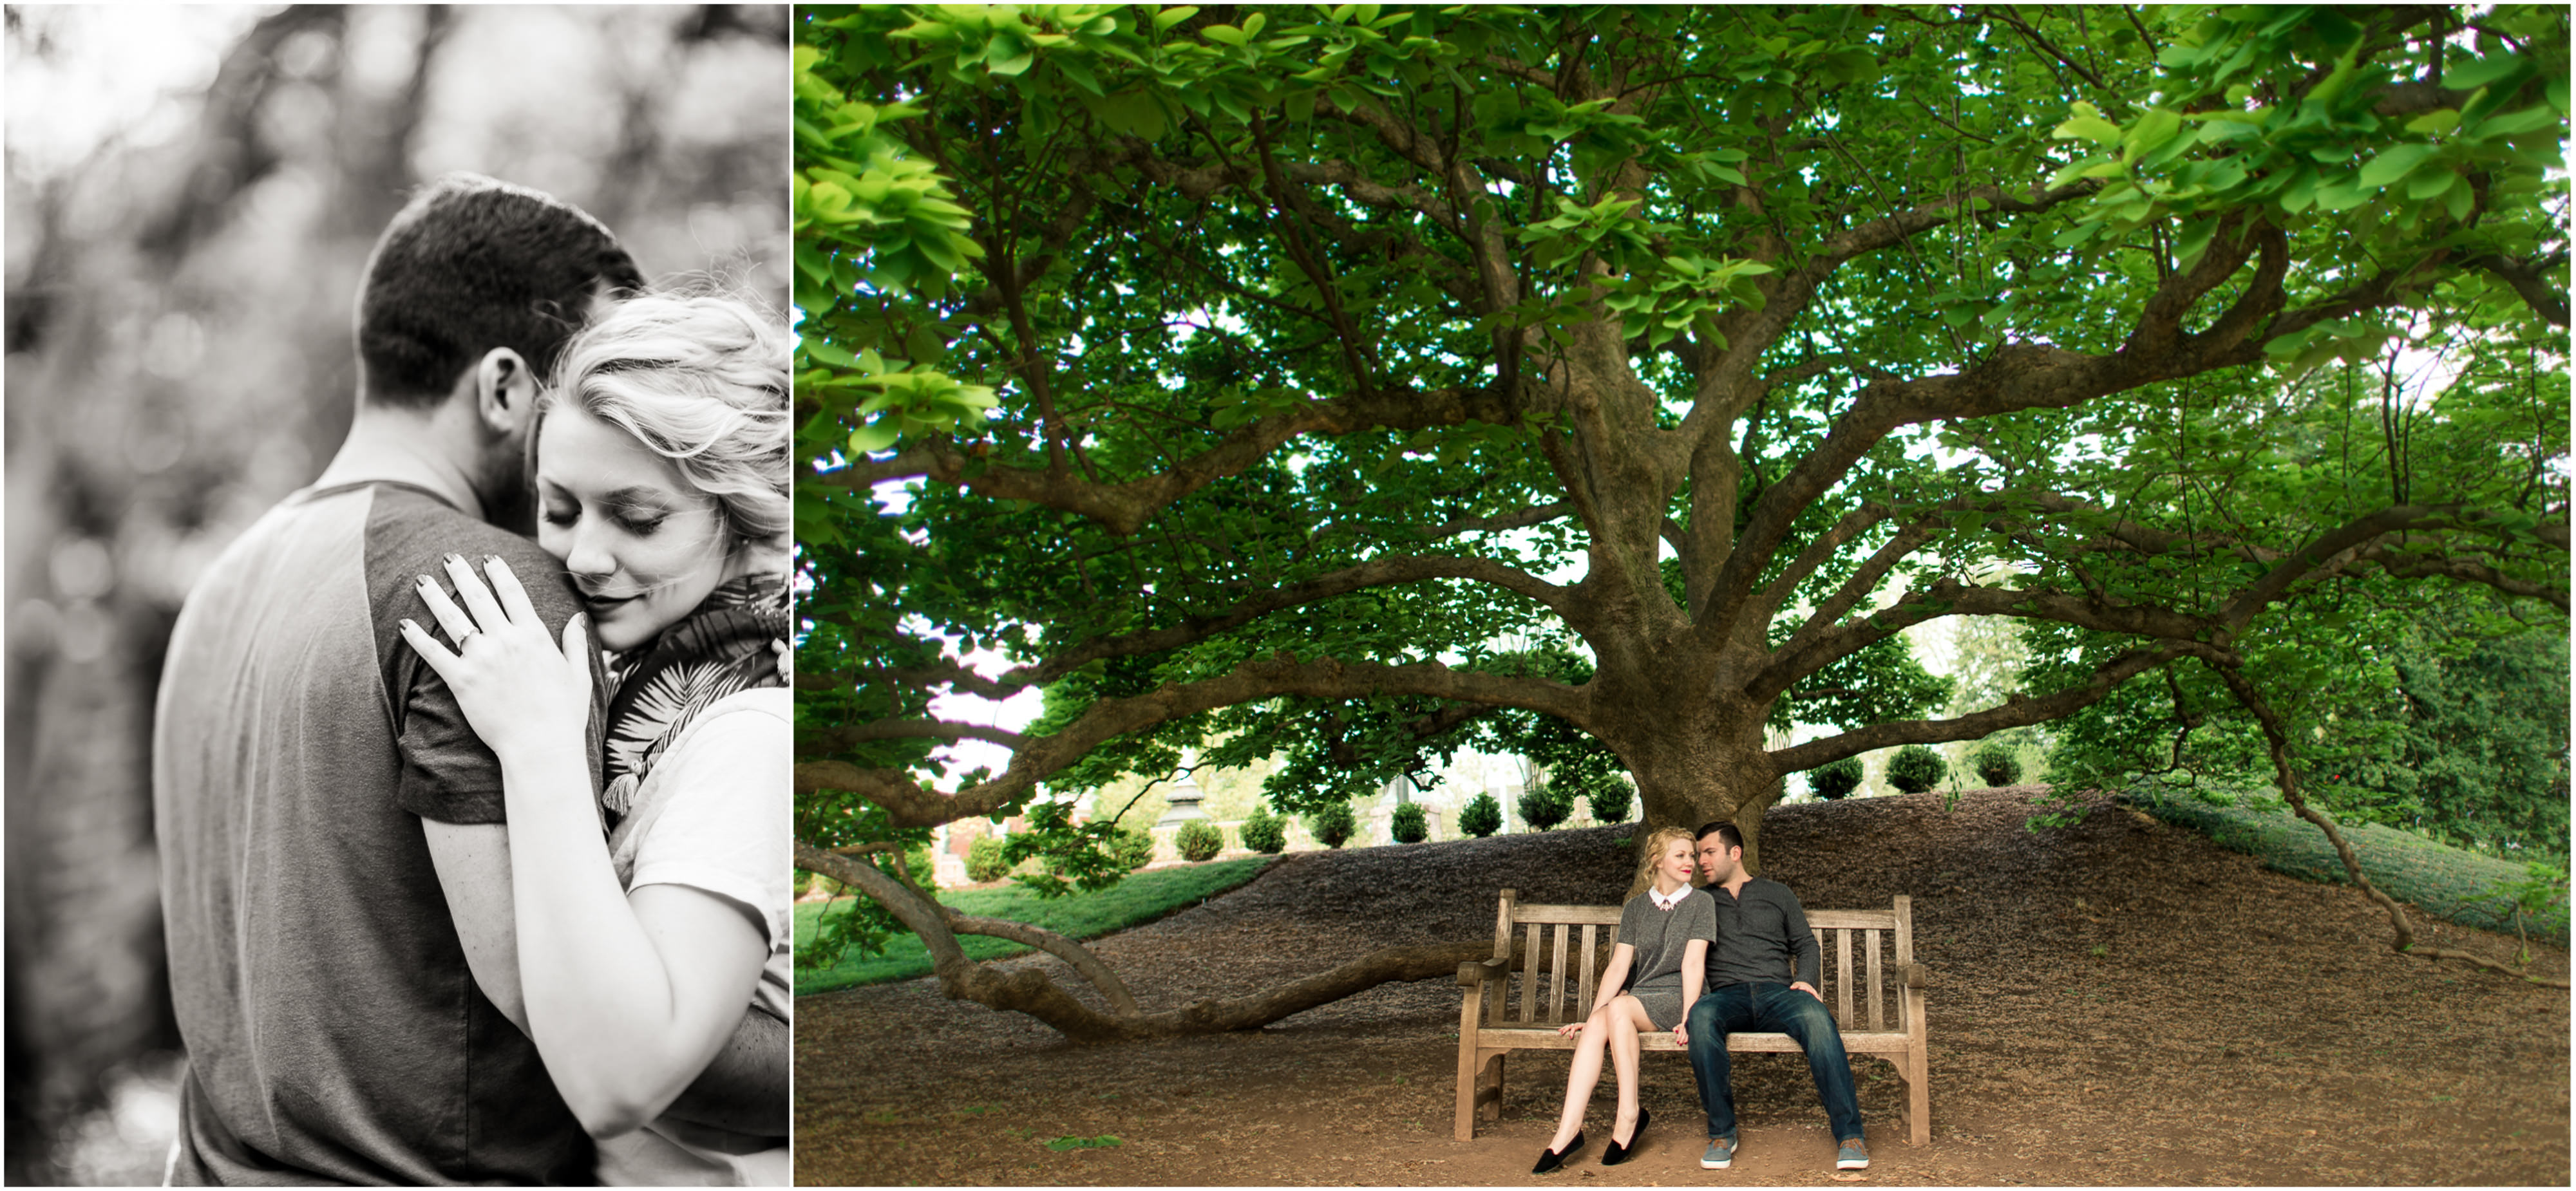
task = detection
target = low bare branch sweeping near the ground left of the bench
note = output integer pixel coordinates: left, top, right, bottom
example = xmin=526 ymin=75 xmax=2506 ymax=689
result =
xmin=796 ymin=840 xmax=1494 ymax=1042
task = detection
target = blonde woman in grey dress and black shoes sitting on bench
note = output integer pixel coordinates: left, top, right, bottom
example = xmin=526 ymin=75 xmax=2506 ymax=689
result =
xmin=1530 ymin=827 xmax=1718 ymax=1176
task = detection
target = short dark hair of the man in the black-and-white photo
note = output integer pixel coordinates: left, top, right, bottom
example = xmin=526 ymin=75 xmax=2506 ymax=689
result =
xmin=358 ymin=173 xmax=644 ymax=408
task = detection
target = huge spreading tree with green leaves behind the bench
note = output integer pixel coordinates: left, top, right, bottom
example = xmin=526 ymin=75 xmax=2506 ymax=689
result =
xmin=796 ymin=5 xmax=2568 ymax=1036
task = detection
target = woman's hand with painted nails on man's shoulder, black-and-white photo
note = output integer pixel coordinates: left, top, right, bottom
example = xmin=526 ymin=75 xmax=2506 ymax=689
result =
xmin=402 ymin=554 xmax=590 ymax=755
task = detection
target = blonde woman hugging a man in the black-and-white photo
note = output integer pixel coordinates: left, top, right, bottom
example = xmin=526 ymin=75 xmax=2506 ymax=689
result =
xmin=404 ymin=296 xmax=793 ymax=1186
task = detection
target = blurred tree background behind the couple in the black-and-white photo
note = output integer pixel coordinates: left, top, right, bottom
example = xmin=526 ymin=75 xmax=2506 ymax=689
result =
xmin=5 ymin=5 xmax=788 ymax=1183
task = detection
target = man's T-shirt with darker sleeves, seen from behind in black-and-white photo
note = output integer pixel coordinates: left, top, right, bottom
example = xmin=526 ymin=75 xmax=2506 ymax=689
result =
xmin=152 ymin=485 xmax=592 ymax=1183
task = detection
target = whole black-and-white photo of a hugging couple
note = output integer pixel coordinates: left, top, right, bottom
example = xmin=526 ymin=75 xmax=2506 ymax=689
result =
xmin=8 ymin=5 xmax=791 ymax=1186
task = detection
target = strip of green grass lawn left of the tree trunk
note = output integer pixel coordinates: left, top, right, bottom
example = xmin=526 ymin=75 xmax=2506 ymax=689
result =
xmin=796 ymin=856 xmax=1275 ymax=995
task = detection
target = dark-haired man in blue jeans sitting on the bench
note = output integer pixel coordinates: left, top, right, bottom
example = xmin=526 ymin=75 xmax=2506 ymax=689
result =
xmin=1687 ymin=822 xmax=1870 ymax=1170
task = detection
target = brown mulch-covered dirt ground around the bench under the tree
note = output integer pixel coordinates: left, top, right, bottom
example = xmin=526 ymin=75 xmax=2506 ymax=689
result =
xmin=796 ymin=789 xmax=2568 ymax=1186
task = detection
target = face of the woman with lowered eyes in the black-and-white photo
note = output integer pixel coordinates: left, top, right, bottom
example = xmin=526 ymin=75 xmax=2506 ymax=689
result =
xmin=536 ymin=405 xmax=729 ymax=650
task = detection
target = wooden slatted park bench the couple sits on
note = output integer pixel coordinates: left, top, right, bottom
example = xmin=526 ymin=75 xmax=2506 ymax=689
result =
xmin=1458 ymin=889 xmax=1932 ymax=1145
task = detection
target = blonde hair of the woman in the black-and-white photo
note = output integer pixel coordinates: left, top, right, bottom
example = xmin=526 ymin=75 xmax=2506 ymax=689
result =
xmin=538 ymin=294 xmax=793 ymax=547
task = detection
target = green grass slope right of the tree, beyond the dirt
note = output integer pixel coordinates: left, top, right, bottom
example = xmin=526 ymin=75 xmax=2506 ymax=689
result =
xmin=2123 ymin=794 xmax=2568 ymax=946
